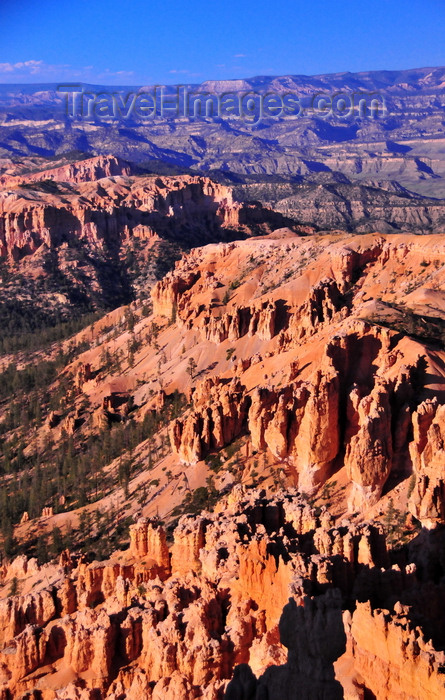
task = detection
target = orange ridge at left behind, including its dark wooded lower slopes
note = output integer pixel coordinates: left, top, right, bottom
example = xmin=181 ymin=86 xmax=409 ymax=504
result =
xmin=0 ymin=156 xmax=283 ymax=318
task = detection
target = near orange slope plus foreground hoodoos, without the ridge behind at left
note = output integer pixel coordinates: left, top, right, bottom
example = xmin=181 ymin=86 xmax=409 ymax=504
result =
xmin=0 ymin=223 xmax=445 ymax=700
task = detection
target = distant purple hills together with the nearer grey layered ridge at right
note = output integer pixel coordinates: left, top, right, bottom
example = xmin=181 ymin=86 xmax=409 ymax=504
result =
xmin=4 ymin=66 xmax=445 ymax=237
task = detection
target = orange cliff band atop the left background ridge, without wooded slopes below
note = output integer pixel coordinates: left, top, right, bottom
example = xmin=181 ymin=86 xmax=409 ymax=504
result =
xmin=0 ymin=158 xmax=240 ymax=260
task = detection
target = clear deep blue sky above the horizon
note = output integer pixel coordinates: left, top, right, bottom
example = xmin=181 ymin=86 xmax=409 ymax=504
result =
xmin=0 ymin=0 xmax=445 ymax=85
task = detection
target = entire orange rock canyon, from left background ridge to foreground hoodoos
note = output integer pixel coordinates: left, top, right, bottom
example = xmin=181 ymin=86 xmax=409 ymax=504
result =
xmin=0 ymin=144 xmax=445 ymax=700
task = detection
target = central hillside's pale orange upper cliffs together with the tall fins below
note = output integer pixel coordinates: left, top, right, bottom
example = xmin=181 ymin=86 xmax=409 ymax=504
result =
xmin=152 ymin=237 xmax=443 ymax=522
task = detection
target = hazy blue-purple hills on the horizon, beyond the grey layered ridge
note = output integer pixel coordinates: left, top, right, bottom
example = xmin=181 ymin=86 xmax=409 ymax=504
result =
xmin=0 ymin=67 xmax=445 ymax=197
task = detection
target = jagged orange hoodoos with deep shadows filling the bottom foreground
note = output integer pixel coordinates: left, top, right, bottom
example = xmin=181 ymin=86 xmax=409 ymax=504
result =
xmin=0 ymin=486 xmax=445 ymax=700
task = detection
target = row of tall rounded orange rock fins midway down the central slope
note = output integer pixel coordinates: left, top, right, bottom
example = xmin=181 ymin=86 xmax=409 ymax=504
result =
xmin=170 ymin=326 xmax=424 ymax=500
